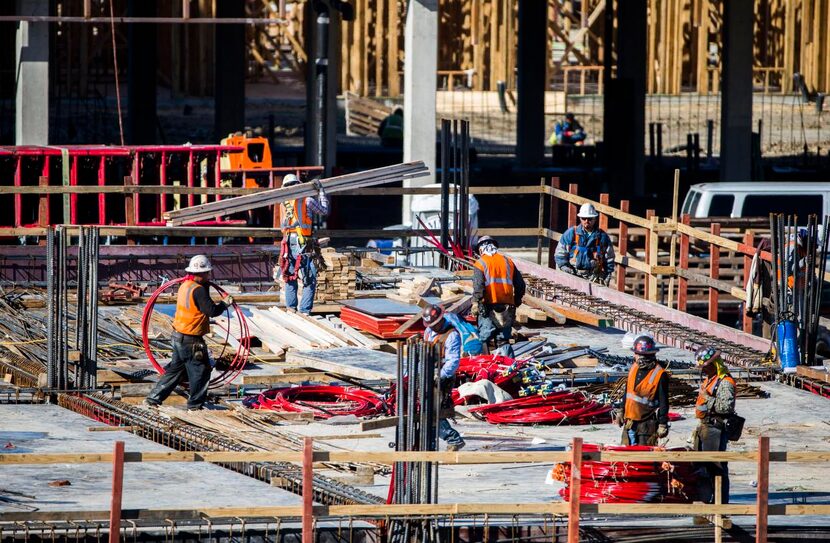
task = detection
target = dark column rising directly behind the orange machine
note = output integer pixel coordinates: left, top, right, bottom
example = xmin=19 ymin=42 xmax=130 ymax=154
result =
xmin=213 ymin=0 xmax=246 ymax=143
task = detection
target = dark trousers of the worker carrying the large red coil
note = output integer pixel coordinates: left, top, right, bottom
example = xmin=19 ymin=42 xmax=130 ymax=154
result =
xmin=147 ymin=332 xmax=211 ymax=409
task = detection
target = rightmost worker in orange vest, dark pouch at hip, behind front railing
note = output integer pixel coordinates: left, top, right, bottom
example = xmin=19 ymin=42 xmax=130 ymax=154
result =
xmin=693 ymin=347 xmax=736 ymax=503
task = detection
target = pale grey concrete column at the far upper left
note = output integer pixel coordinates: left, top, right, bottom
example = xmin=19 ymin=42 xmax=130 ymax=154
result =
xmin=14 ymin=0 xmax=49 ymax=145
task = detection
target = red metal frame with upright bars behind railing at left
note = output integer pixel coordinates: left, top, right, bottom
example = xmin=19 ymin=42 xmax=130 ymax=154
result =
xmin=0 ymin=145 xmax=321 ymax=227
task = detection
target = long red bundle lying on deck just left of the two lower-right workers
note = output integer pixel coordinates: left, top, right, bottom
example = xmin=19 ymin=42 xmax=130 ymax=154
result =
xmin=470 ymin=392 xmax=611 ymax=425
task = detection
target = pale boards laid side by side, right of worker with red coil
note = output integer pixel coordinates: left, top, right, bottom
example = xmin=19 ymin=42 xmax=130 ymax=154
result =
xmin=215 ymin=307 xmax=382 ymax=356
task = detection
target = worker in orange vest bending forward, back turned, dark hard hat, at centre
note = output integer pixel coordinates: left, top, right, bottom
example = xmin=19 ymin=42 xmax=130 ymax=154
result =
xmin=470 ymin=236 xmax=525 ymax=357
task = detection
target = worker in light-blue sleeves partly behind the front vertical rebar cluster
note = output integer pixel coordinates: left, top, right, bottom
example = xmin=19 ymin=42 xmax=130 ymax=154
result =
xmin=421 ymin=305 xmax=481 ymax=451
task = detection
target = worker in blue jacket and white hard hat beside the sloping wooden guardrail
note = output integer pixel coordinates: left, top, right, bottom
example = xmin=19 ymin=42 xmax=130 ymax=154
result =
xmin=554 ymin=204 xmax=614 ymax=286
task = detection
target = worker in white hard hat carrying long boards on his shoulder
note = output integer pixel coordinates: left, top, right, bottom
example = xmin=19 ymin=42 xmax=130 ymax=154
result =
xmin=275 ymin=174 xmax=329 ymax=314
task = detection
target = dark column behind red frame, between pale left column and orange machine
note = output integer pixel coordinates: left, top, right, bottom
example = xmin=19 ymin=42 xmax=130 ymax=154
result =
xmin=124 ymin=0 xmax=158 ymax=145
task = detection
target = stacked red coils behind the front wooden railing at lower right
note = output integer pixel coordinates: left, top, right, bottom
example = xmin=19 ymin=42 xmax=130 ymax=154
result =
xmin=551 ymin=444 xmax=697 ymax=503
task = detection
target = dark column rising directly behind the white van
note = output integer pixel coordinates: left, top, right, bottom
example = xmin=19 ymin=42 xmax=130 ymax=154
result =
xmin=720 ymin=0 xmax=754 ymax=181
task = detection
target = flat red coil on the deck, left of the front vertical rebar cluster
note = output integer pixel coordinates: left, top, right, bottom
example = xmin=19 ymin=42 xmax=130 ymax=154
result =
xmin=243 ymin=385 xmax=390 ymax=419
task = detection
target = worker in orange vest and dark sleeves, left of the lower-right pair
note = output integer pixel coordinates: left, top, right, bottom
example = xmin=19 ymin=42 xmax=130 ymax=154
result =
xmin=618 ymin=336 xmax=669 ymax=445
